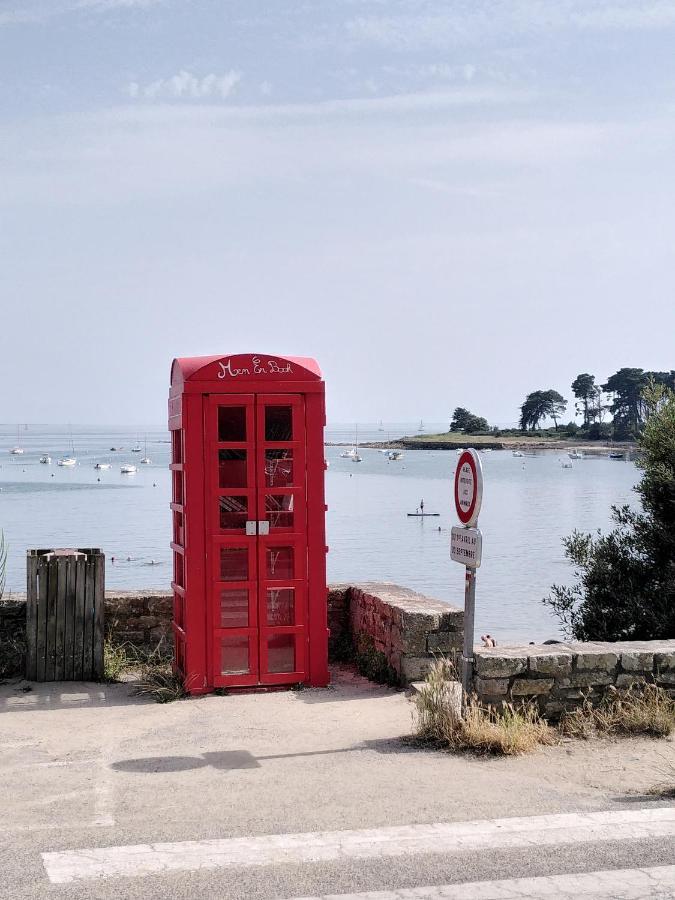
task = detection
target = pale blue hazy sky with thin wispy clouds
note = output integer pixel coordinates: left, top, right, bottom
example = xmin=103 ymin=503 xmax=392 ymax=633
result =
xmin=0 ymin=0 xmax=675 ymax=426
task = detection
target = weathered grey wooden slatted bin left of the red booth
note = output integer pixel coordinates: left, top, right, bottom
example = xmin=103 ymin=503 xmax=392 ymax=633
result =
xmin=26 ymin=548 xmax=105 ymax=681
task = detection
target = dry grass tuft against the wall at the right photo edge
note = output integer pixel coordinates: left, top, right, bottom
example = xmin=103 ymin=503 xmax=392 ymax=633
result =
xmin=560 ymin=683 xmax=675 ymax=738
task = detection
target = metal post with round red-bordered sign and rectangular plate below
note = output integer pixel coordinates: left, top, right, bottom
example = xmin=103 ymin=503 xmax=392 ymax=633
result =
xmin=450 ymin=450 xmax=483 ymax=705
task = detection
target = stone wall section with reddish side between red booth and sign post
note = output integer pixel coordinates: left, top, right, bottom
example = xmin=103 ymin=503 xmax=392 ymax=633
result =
xmin=348 ymin=582 xmax=464 ymax=685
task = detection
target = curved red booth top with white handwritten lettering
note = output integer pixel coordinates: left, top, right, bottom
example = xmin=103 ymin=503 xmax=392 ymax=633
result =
xmin=171 ymin=353 xmax=322 ymax=396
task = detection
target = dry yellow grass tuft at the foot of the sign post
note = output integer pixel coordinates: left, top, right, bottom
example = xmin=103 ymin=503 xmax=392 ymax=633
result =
xmin=415 ymin=659 xmax=556 ymax=756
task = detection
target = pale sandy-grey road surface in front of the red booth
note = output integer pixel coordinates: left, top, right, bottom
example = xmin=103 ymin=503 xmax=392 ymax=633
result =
xmin=0 ymin=671 xmax=675 ymax=900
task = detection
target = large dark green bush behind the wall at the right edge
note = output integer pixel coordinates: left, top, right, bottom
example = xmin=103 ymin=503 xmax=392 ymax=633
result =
xmin=544 ymin=380 xmax=675 ymax=641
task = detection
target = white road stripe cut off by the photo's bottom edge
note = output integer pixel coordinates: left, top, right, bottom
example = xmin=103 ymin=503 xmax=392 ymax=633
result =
xmin=296 ymin=866 xmax=675 ymax=900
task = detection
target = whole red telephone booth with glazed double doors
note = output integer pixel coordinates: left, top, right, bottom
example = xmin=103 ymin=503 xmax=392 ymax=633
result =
xmin=169 ymin=353 xmax=328 ymax=694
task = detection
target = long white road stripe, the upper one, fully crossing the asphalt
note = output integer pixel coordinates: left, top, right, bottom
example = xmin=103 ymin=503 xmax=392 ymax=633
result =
xmin=42 ymin=807 xmax=675 ymax=884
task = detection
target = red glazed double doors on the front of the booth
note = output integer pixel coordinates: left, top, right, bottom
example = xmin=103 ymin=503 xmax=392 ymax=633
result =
xmin=205 ymin=394 xmax=307 ymax=687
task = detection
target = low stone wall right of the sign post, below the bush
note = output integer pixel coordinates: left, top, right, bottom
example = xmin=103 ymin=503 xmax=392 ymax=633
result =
xmin=474 ymin=640 xmax=675 ymax=718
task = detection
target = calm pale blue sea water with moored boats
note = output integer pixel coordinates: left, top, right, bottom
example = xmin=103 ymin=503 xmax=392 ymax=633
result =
xmin=0 ymin=423 xmax=639 ymax=642
